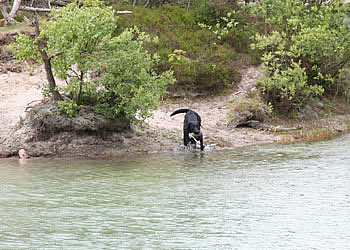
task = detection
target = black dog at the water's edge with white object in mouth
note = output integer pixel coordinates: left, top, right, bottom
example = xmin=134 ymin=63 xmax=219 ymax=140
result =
xmin=170 ymin=109 xmax=204 ymax=150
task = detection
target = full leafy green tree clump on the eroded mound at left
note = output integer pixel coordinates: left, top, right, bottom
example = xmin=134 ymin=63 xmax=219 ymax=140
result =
xmin=11 ymin=0 xmax=175 ymax=121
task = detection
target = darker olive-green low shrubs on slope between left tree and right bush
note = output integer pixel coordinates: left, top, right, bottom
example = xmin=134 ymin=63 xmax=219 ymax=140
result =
xmin=115 ymin=1 xmax=239 ymax=92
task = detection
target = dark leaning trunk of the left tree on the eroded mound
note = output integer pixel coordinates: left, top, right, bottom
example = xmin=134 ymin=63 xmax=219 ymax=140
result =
xmin=33 ymin=18 xmax=63 ymax=101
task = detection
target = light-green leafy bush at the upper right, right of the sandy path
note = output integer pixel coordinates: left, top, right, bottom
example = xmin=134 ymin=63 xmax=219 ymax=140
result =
xmin=250 ymin=0 xmax=350 ymax=110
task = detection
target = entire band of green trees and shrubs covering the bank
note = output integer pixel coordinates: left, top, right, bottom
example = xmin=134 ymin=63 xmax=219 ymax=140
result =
xmin=6 ymin=0 xmax=350 ymax=120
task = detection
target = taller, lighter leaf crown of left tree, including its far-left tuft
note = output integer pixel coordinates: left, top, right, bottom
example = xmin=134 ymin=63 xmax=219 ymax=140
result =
xmin=10 ymin=0 xmax=116 ymax=105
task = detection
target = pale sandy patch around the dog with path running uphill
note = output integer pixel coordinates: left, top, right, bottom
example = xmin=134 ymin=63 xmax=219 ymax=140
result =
xmin=148 ymin=66 xmax=280 ymax=147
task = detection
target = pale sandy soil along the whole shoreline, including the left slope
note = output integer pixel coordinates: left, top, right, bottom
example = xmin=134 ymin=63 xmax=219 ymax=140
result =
xmin=0 ymin=28 xmax=350 ymax=157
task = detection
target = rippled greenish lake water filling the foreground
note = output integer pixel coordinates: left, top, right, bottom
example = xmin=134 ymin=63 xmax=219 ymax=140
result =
xmin=0 ymin=135 xmax=350 ymax=249
